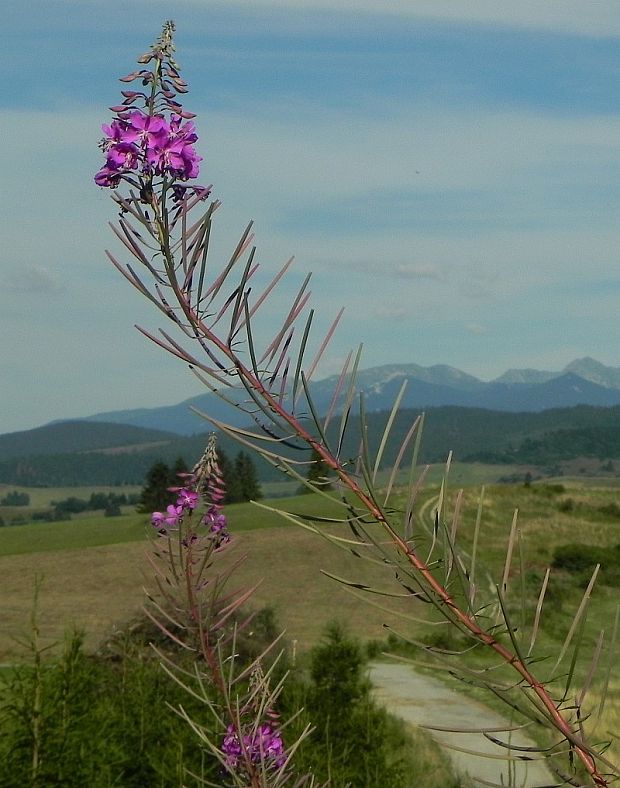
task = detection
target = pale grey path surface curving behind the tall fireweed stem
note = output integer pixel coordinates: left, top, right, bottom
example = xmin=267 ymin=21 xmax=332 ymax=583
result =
xmin=370 ymin=663 xmax=557 ymax=788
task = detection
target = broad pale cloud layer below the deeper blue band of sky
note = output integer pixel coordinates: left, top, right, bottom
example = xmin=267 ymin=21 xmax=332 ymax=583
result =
xmin=0 ymin=81 xmax=620 ymax=430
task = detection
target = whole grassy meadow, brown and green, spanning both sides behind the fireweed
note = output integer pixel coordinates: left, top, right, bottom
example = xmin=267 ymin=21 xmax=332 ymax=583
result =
xmin=0 ymin=468 xmax=620 ymax=760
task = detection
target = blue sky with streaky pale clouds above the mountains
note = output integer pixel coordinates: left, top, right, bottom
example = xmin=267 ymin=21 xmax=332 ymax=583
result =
xmin=0 ymin=0 xmax=620 ymax=432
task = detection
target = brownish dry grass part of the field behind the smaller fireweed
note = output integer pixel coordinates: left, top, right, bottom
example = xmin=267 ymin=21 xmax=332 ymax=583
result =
xmin=0 ymin=524 xmax=422 ymax=663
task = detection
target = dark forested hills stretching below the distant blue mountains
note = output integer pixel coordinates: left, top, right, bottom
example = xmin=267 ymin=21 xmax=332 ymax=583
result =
xmin=0 ymin=405 xmax=620 ymax=486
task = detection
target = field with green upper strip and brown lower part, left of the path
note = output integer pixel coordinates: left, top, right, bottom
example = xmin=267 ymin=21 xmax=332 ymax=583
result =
xmin=0 ymin=495 xmax=424 ymax=662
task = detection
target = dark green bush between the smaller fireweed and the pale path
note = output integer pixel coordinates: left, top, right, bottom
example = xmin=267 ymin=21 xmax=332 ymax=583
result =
xmin=282 ymin=623 xmax=460 ymax=788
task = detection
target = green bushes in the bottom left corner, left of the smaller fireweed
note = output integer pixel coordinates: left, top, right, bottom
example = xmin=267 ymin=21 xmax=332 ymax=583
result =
xmin=0 ymin=635 xmax=218 ymax=788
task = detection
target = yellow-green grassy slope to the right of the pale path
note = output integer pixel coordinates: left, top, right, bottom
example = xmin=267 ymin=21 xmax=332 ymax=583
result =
xmin=404 ymin=478 xmax=620 ymax=763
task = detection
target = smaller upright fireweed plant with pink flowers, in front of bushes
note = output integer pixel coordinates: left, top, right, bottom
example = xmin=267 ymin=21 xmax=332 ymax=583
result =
xmin=146 ymin=436 xmax=313 ymax=786
